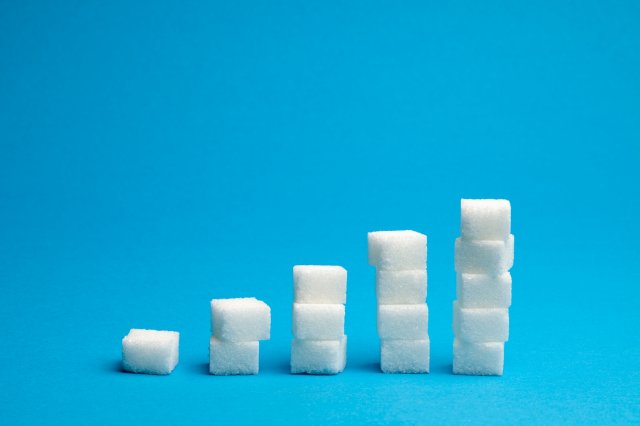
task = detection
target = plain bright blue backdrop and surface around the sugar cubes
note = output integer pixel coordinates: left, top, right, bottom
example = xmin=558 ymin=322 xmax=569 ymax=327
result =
xmin=0 ymin=1 xmax=640 ymax=425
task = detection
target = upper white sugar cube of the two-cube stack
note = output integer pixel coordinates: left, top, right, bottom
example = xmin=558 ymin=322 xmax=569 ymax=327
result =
xmin=211 ymin=297 xmax=271 ymax=342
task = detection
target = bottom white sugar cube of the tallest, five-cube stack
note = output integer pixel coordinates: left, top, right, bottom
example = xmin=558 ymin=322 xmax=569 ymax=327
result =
xmin=453 ymin=339 xmax=504 ymax=376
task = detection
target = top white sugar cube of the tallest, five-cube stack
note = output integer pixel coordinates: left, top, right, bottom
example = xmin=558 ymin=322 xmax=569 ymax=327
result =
xmin=460 ymin=199 xmax=511 ymax=240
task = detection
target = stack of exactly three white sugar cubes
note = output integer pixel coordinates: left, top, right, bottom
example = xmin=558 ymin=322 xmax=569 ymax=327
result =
xmin=291 ymin=265 xmax=347 ymax=374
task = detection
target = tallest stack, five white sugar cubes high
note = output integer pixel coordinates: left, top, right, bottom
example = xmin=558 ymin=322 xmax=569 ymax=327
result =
xmin=453 ymin=199 xmax=514 ymax=376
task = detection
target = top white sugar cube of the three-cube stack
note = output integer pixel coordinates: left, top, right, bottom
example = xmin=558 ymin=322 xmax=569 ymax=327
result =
xmin=293 ymin=265 xmax=347 ymax=304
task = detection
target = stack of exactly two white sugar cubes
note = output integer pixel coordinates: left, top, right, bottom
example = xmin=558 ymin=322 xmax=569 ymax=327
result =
xmin=209 ymin=297 xmax=271 ymax=376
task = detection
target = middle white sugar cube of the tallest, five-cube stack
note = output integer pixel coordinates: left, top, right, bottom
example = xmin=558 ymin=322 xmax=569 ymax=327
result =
xmin=456 ymin=272 xmax=511 ymax=308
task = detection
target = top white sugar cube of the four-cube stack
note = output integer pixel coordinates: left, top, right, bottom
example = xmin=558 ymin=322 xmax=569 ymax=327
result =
xmin=368 ymin=231 xmax=427 ymax=270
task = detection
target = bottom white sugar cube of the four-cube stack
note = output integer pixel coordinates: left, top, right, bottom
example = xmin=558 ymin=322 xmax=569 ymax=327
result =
xmin=380 ymin=339 xmax=430 ymax=373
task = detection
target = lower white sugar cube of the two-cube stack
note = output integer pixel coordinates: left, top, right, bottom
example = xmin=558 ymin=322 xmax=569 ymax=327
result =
xmin=209 ymin=337 xmax=260 ymax=376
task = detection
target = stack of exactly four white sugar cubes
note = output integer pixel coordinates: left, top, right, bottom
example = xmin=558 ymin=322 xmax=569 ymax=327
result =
xmin=368 ymin=231 xmax=430 ymax=373
